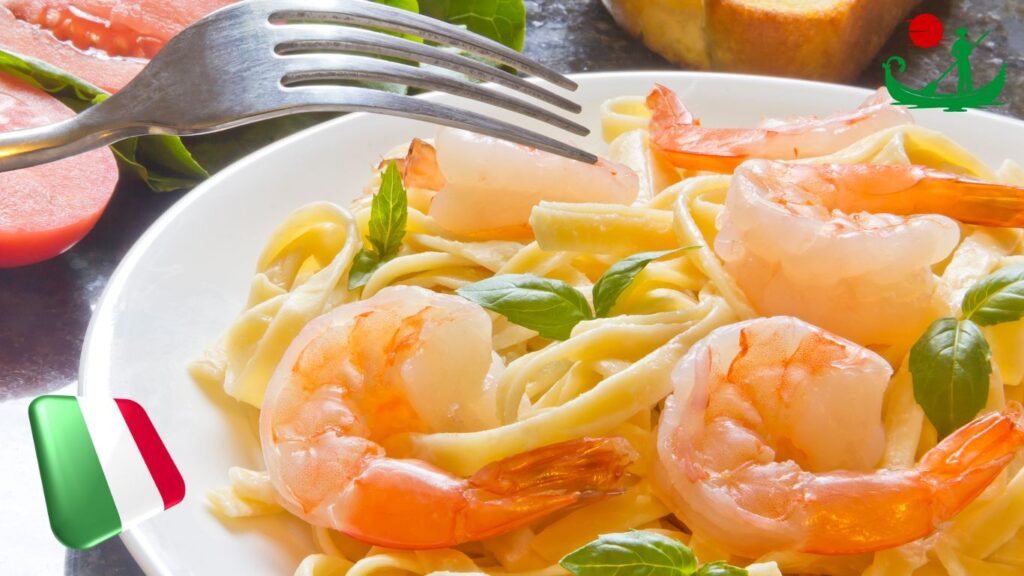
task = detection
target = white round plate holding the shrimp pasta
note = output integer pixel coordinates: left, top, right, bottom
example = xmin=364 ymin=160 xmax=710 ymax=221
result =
xmin=80 ymin=72 xmax=1024 ymax=576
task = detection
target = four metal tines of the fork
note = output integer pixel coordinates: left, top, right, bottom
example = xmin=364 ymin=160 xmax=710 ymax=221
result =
xmin=260 ymin=0 xmax=597 ymax=162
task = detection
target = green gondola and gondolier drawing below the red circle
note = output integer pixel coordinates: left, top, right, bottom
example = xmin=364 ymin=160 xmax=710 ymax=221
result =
xmin=882 ymin=28 xmax=1007 ymax=112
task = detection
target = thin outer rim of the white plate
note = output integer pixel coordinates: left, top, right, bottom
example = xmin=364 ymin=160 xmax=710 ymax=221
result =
xmin=76 ymin=69 xmax=1024 ymax=576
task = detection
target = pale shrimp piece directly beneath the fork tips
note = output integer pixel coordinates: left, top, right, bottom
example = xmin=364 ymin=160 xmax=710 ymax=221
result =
xmin=430 ymin=128 xmax=640 ymax=238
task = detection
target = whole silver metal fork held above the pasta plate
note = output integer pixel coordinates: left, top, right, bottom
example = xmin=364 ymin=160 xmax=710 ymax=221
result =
xmin=0 ymin=0 xmax=597 ymax=171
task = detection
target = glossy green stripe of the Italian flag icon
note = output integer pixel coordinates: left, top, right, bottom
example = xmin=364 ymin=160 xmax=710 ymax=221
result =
xmin=29 ymin=396 xmax=121 ymax=548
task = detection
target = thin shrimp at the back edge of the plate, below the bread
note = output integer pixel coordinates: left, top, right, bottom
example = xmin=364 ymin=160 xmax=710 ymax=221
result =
xmin=647 ymin=85 xmax=913 ymax=172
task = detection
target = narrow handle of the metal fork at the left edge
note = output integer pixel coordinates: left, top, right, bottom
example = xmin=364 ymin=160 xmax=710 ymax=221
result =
xmin=0 ymin=109 xmax=148 ymax=172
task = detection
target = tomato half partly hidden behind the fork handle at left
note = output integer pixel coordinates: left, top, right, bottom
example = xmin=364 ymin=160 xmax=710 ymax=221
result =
xmin=0 ymin=74 xmax=118 ymax=268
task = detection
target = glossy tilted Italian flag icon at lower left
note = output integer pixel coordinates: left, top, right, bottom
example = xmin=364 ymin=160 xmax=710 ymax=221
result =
xmin=29 ymin=396 xmax=185 ymax=548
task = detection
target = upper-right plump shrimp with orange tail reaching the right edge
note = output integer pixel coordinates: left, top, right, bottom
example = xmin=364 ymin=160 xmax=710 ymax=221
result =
xmin=715 ymin=160 xmax=1024 ymax=345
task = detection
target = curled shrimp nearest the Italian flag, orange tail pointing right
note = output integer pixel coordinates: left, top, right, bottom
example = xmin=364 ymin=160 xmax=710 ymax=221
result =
xmin=260 ymin=287 xmax=636 ymax=548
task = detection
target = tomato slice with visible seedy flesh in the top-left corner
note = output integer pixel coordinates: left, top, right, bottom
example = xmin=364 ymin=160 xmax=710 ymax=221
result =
xmin=0 ymin=0 xmax=234 ymax=92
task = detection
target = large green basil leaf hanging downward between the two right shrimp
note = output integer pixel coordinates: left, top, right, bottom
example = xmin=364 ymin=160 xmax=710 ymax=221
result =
xmin=909 ymin=318 xmax=992 ymax=438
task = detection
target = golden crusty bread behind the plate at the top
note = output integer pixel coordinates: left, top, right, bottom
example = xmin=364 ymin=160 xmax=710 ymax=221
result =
xmin=603 ymin=0 xmax=920 ymax=81
